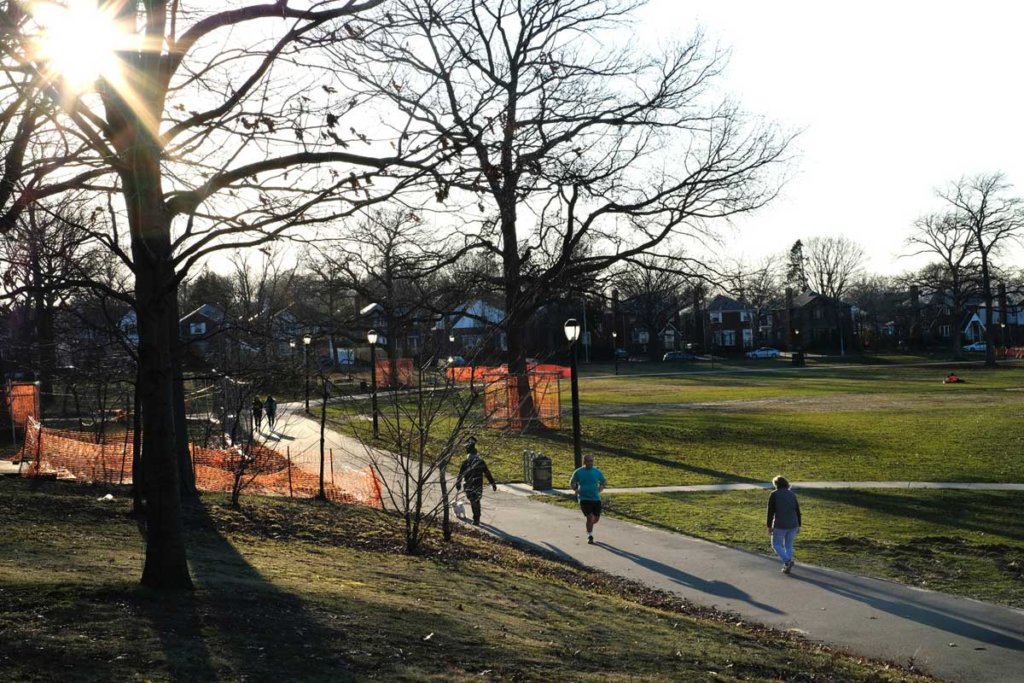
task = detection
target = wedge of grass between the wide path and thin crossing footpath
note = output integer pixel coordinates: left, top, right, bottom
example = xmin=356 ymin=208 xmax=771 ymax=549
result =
xmin=549 ymin=488 xmax=1024 ymax=607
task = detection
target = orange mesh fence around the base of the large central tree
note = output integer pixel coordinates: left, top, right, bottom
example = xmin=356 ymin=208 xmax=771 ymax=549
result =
xmin=482 ymin=370 xmax=561 ymax=430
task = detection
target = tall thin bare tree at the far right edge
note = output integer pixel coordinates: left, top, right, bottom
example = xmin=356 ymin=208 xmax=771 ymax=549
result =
xmin=936 ymin=173 xmax=1024 ymax=367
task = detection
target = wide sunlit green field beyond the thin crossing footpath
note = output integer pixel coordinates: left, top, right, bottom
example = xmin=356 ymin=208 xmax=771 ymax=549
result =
xmin=334 ymin=361 xmax=1024 ymax=486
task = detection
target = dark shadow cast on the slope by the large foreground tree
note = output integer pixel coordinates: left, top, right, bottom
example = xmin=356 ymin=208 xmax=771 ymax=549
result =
xmin=137 ymin=501 xmax=355 ymax=681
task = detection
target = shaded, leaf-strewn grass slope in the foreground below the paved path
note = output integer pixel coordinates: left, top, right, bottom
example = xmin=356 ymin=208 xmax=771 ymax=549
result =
xmin=0 ymin=479 xmax=926 ymax=681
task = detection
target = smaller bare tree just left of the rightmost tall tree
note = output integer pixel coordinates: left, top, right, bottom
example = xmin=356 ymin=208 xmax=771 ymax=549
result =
xmin=907 ymin=212 xmax=978 ymax=357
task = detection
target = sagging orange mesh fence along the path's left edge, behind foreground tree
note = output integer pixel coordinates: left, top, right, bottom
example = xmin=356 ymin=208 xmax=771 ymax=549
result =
xmin=22 ymin=419 xmax=383 ymax=508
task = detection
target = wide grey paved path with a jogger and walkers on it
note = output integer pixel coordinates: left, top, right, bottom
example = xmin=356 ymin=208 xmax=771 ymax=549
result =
xmin=264 ymin=404 xmax=1024 ymax=682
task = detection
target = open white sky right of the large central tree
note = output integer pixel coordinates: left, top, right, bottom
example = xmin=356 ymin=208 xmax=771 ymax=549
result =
xmin=637 ymin=0 xmax=1024 ymax=274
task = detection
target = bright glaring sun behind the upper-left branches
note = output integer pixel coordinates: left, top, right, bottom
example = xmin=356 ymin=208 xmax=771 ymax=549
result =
xmin=31 ymin=0 xmax=129 ymax=93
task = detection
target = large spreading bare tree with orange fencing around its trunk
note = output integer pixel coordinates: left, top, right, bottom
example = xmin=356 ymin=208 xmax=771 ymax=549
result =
xmin=337 ymin=0 xmax=788 ymax=424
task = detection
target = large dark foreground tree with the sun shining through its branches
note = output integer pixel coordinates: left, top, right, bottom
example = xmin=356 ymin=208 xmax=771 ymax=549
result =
xmin=0 ymin=0 xmax=435 ymax=589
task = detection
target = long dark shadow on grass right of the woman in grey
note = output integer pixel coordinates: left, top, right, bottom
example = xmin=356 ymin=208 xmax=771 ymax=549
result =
xmin=800 ymin=488 xmax=1024 ymax=542
